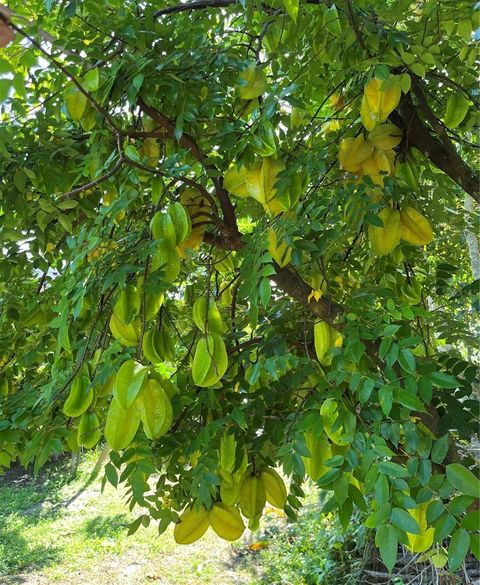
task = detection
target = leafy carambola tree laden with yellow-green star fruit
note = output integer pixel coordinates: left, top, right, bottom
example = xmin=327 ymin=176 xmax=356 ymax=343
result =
xmin=0 ymin=0 xmax=480 ymax=570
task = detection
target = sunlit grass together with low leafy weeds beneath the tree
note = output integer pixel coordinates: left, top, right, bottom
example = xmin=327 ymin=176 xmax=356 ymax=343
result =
xmin=0 ymin=451 xmax=360 ymax=585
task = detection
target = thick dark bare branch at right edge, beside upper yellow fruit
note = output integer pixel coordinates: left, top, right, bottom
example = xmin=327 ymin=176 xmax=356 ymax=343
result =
xmin=390 ymin=94 xmax=480 ymax=202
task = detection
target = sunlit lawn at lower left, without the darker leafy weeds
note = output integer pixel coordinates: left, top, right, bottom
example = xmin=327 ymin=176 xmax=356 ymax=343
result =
xmin=0 ymin=453 xmax=255 ymax=585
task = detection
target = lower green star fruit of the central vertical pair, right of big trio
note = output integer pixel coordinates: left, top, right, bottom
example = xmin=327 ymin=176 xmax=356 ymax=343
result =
xmin=192 ymin=333 xmax=228 ymax=388
